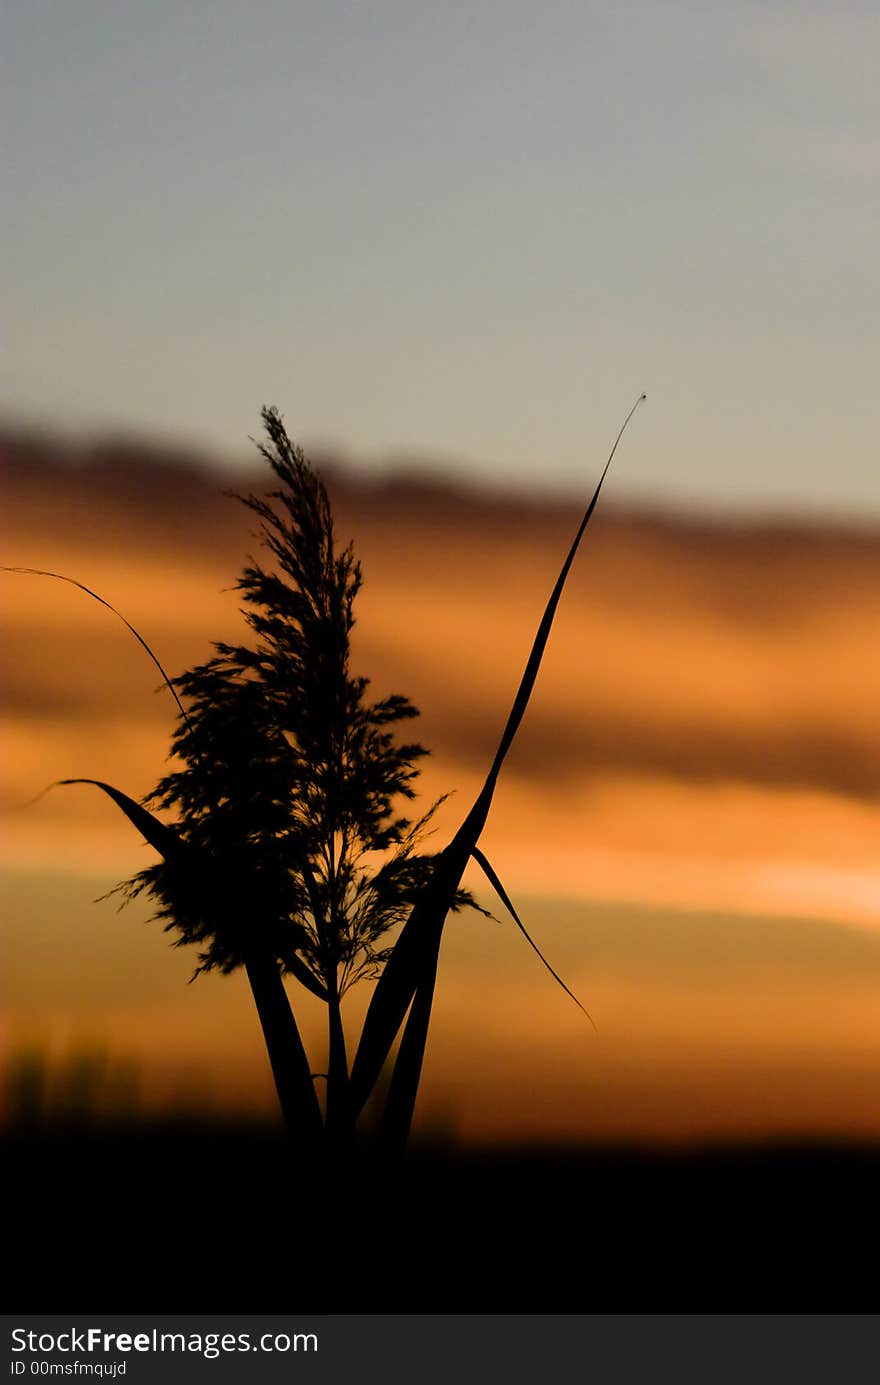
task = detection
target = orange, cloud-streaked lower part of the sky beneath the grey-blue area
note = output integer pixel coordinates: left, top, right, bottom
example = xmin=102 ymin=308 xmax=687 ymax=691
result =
xmin=1 ymin=452 xmax=880 ymax=1140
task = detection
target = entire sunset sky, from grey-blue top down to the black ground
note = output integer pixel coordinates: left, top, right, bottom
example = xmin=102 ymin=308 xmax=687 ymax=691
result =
xmin=0 ymin=0 xmax=880 ymax=1141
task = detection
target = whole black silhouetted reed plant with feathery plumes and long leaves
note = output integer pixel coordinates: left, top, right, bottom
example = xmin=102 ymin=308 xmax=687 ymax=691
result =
xmin=3 ymin=396 xmax=644 ymax=1158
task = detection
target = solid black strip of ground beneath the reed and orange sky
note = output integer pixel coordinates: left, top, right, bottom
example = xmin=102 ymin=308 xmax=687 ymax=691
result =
xmin=4 ymin=1123 xmax=880 ymax=1313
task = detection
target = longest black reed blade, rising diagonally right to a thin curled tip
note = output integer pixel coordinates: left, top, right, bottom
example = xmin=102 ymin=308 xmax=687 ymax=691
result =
xmin=351 ymin=395 xmax=646 ymax=1111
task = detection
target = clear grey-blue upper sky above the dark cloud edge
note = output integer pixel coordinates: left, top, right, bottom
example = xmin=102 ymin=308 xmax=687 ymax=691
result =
xmin=0 ymin=0 xmax=880 ymax=515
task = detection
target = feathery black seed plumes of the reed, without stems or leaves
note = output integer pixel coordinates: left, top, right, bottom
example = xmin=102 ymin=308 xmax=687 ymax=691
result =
xmin=125 ymin=409 xmax=473 ymax=999
